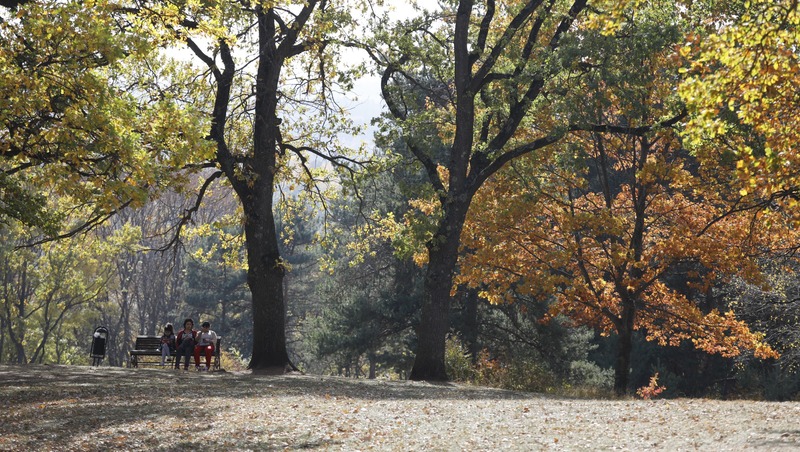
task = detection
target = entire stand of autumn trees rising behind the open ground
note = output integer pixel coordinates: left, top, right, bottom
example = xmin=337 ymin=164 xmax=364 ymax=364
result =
xmin=0 ymin=0 xmax=800 ymax=400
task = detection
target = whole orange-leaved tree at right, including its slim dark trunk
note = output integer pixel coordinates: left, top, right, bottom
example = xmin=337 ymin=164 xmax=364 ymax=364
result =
xmin=457 ymin=3 xmax=793 ymax=392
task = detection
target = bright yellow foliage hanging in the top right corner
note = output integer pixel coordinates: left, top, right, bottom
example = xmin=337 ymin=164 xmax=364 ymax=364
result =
xmin=680 ymin=0 xmax=800 ymax=208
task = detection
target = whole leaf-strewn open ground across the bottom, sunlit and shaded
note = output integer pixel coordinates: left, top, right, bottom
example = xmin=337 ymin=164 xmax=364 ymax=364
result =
xmin=0 ymin=366 xmax=800 ymax=451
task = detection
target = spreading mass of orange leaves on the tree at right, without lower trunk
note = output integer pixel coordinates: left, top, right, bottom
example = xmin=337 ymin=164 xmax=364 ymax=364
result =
xmin=458 ymin=125 xmax=788 ymax=357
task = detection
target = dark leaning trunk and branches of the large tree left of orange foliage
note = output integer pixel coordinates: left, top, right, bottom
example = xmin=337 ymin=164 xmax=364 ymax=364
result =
xmin=381 ymin=0 xmax=586 ymax=380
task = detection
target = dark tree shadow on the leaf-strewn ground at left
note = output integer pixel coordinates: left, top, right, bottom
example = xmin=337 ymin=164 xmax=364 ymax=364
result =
xmin=0 ymin=365 xmax=543 ymax=450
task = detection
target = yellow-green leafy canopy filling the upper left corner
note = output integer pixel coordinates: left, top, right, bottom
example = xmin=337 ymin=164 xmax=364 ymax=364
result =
xmin=0 ymin=2 xmax=212 ymax=236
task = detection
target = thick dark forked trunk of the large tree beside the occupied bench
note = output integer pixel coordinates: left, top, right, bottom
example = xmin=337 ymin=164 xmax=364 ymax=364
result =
xmin=203 ymin=6 xmax=306 ymax=372
